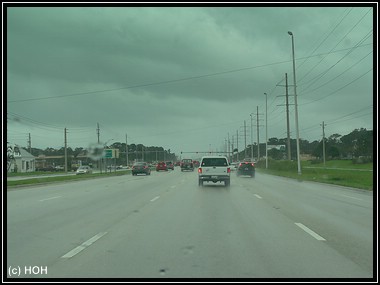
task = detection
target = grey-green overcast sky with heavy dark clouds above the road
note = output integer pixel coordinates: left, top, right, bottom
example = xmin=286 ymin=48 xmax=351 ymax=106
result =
xmin=3 ymin=4 xmax=374 ymax=158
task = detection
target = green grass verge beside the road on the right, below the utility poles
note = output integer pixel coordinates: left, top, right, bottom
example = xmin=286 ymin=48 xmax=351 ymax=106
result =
xmin=257 ymin=160 xmax=373 ymax=191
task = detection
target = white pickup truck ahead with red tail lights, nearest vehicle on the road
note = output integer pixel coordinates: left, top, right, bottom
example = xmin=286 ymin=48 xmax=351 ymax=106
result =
xmin=198 ymin=156 xmax=231 ymax=186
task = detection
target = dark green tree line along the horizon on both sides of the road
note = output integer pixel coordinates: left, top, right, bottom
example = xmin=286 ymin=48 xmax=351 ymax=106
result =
xmin=31 ymin=128 xmax=373 ymax=165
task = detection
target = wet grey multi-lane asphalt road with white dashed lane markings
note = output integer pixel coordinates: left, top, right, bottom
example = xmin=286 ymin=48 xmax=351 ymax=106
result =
xmin=6 ymin=168 xmax=373 ymax=280
